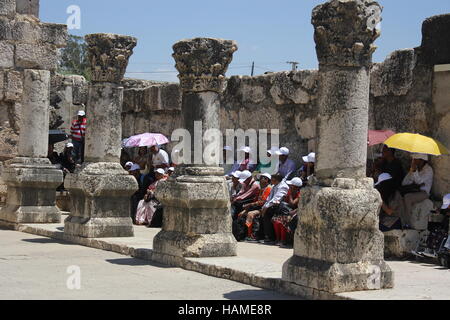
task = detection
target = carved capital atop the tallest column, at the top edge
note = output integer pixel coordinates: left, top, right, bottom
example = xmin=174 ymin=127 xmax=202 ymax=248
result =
xmin=312 ymin=0 xmax=382 ymax=67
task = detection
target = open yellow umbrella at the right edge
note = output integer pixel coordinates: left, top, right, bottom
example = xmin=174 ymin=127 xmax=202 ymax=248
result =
xmin=384 ymin=133 xmax=449 ymax=156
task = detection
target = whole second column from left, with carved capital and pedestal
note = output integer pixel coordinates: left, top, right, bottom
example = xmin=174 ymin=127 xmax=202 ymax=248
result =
xmin=64 ymin=34 xmax=138 ymax=238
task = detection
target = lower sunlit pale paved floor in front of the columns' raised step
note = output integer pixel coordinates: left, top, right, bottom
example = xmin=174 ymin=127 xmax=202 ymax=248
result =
xmin=0 ymin=229 xmax=302 ymax=300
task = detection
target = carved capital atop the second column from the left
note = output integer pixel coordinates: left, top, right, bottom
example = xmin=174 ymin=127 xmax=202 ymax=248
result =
xmin=85 ymin=33 xmax=137 ymax=83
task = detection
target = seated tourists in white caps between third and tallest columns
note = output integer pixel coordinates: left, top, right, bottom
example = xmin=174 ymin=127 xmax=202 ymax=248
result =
xmin=224 ymin=146 xmax=316 ymax=248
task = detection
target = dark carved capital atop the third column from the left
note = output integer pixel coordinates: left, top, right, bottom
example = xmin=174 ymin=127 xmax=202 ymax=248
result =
xmin=173 ymin=38 xmax=237 ymax=93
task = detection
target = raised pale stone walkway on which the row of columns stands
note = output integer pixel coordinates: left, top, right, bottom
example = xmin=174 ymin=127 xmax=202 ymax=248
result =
xmin=0 ymin=216 xmax=450 ymax=300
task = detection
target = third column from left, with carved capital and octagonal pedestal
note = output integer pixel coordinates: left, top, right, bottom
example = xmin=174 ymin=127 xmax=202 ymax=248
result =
xmin=153 ymin=38 xmax=237 ymax=263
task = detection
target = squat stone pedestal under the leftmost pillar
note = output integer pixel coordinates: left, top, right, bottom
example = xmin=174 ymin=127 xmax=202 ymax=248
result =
xmin=0 ymin=157 xmax=63 ymax=223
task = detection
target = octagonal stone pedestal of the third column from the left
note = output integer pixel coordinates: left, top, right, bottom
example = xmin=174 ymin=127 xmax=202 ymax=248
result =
xmin=153 ymin=167 xmax=237 ymax=257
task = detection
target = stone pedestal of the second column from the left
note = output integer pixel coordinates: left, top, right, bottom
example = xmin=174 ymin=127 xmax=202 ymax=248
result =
xmin=64 ymin=163 xmax=138 ymax=238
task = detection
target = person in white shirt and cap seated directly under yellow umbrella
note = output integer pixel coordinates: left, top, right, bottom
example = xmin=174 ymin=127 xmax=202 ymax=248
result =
xmin=402 ymin=153 xmax=434 ymax=227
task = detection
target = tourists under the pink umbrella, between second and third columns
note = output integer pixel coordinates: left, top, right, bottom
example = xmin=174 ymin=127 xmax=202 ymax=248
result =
xmin=121 ymin=145 xmax=175 ymax=228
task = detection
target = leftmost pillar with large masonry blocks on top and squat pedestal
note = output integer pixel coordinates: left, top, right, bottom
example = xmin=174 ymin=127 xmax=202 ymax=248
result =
xmin=0 ymin=0 xmax=67 ymax=223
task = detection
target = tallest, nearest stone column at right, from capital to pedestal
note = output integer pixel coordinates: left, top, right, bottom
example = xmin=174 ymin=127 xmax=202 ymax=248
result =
xmin=283 ymin=0 xmax=393 ymax=293
